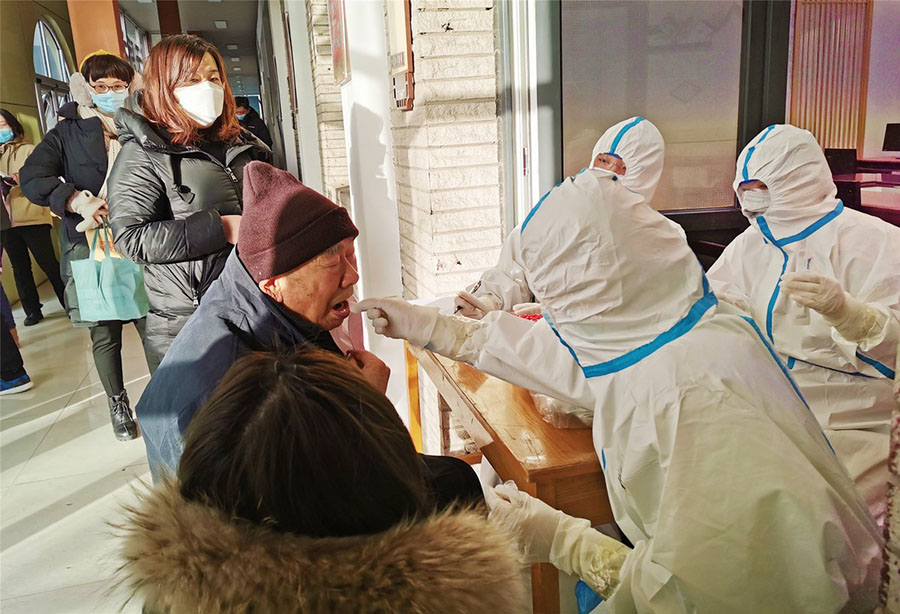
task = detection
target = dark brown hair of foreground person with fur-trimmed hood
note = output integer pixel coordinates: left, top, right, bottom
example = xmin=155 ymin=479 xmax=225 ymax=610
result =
xmin=178 ymin=350 xmax=431 ymax=537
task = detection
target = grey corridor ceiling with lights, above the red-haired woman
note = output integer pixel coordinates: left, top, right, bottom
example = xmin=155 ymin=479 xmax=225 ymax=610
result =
xmin=119 ymin=0 xmax=259 ymax=94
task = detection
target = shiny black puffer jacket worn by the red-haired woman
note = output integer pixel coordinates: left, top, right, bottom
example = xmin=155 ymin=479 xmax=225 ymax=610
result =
xmin=108 ymin=104 xmax=271 ymax=358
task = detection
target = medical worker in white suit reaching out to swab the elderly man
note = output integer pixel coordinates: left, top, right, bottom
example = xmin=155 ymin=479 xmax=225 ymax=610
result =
xmin=358 ymin=164 xmax=881 ymax=614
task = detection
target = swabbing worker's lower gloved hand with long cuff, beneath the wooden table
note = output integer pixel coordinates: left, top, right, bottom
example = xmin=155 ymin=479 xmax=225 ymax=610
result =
xmin=485 ymin=482 xmax=631 ymax=599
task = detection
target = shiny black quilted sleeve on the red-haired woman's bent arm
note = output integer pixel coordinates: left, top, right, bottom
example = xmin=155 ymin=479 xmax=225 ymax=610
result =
xmin=109 ymin=141 xmax=226 ymax=264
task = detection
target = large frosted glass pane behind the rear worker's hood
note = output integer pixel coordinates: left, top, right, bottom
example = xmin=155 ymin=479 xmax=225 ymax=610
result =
xmin=561 ymin=0 xmax=742 ymax=209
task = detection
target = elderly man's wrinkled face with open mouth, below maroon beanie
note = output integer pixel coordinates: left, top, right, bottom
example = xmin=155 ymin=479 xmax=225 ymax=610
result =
xmin=259 ymin=239 xmax=359 ymax=330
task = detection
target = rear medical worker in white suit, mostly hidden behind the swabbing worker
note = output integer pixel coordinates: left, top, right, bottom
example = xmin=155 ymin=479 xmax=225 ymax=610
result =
xmin=455 ymin=117 xmax=665 ymax=319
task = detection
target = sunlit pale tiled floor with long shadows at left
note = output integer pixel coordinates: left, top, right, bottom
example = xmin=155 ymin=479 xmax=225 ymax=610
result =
xmin=0 ymin=284 xmax=150 ymax=614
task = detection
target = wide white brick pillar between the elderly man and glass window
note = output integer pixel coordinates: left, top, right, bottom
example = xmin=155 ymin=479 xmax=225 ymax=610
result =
xmin=388 ymin=0 xmax=503 ymax=298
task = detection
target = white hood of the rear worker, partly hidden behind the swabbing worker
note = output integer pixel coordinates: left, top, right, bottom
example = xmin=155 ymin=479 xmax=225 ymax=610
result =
xmin=591 ymin=117 xmax=665 ymax=202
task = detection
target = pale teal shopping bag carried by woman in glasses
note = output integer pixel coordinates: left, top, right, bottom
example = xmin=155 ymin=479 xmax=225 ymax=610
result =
xmin=72 ymin=219 xmax=150 ymax=322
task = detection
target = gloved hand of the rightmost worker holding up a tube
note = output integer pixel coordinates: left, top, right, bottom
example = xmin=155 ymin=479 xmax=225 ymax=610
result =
xmin=781 ymin=273 xmax=886 ymax=343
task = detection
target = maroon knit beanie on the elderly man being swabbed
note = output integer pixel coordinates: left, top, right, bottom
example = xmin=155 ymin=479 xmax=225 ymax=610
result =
xmin=238 ymin=162 xmax=359 ymax=282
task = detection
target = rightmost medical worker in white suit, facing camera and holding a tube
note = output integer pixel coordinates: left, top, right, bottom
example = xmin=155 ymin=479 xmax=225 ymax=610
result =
xmin=709 ymin=126 xmax=900 ymax=520
